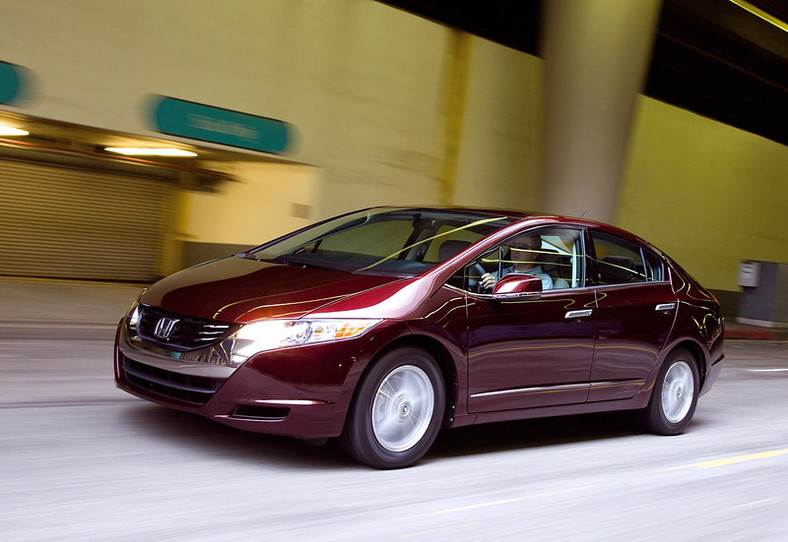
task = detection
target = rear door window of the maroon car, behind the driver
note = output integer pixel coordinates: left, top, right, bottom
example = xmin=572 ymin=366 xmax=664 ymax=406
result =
xmin=591 ymin=232 xmax=648 ymax=285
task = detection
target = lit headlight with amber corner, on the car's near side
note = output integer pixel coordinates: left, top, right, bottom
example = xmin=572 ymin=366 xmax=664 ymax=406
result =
xmin=232 ymin=319 xmax=381 ymax=363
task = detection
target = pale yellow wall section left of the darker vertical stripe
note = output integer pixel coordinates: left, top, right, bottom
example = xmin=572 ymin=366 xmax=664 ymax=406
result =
xmin=0 ymin=0 xmax=450 ymax=218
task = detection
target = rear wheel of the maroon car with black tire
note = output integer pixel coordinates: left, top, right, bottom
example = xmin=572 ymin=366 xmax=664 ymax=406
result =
xmin=641 ymin=349 xmax=700 ymax=435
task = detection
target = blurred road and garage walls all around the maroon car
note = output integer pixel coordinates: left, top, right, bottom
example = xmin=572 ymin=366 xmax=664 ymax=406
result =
xmin=0 ymin=0 xmax=788 ymax=542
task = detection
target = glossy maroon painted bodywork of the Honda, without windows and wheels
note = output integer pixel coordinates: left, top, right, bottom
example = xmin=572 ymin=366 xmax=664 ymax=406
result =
xmin=115 ymin=209 xmax=723 ymax=466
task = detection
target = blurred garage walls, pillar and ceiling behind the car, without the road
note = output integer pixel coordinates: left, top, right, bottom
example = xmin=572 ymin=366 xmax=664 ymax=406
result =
xmin=0 ymin=0 xmax=788 ymax=314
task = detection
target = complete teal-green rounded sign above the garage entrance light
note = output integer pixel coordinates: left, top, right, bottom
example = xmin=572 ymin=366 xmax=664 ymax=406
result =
xmin=153 ymin=96 xmax=292 ymax=154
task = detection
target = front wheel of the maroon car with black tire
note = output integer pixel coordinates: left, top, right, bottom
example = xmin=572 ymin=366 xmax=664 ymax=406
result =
xmin=339 ymin=347 xmax=446 ymax=469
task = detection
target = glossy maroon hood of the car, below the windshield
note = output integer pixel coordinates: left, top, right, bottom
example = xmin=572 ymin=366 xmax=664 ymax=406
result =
xmin=141 ymin=257 xmax=401 ymax=323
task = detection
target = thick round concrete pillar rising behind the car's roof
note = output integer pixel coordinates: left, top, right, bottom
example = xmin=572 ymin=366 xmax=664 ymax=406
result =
xmin=541 ymin=0 xmax=661 ymax=222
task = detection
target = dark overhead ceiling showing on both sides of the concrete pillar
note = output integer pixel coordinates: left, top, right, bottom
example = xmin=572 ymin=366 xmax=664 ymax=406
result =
xmin=382 ymin=0 xmax=788 ymax=145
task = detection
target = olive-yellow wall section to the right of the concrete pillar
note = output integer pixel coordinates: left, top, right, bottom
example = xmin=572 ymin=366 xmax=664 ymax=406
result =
xmin=617 ymin=97 xmax=788 ymax=290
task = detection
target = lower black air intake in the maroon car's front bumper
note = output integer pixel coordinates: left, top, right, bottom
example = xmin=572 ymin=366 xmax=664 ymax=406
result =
xmin=123 ymin=356 xmax=224 ymax=406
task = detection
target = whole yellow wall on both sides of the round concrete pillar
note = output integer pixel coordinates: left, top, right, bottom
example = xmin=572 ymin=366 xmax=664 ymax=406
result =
xmin=0 ymin=0 xmax=788 ymax=290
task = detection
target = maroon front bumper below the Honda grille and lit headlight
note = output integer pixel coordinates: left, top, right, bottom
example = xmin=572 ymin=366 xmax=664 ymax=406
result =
xmin=115 ymin=318 xmax=388 ymax=438
